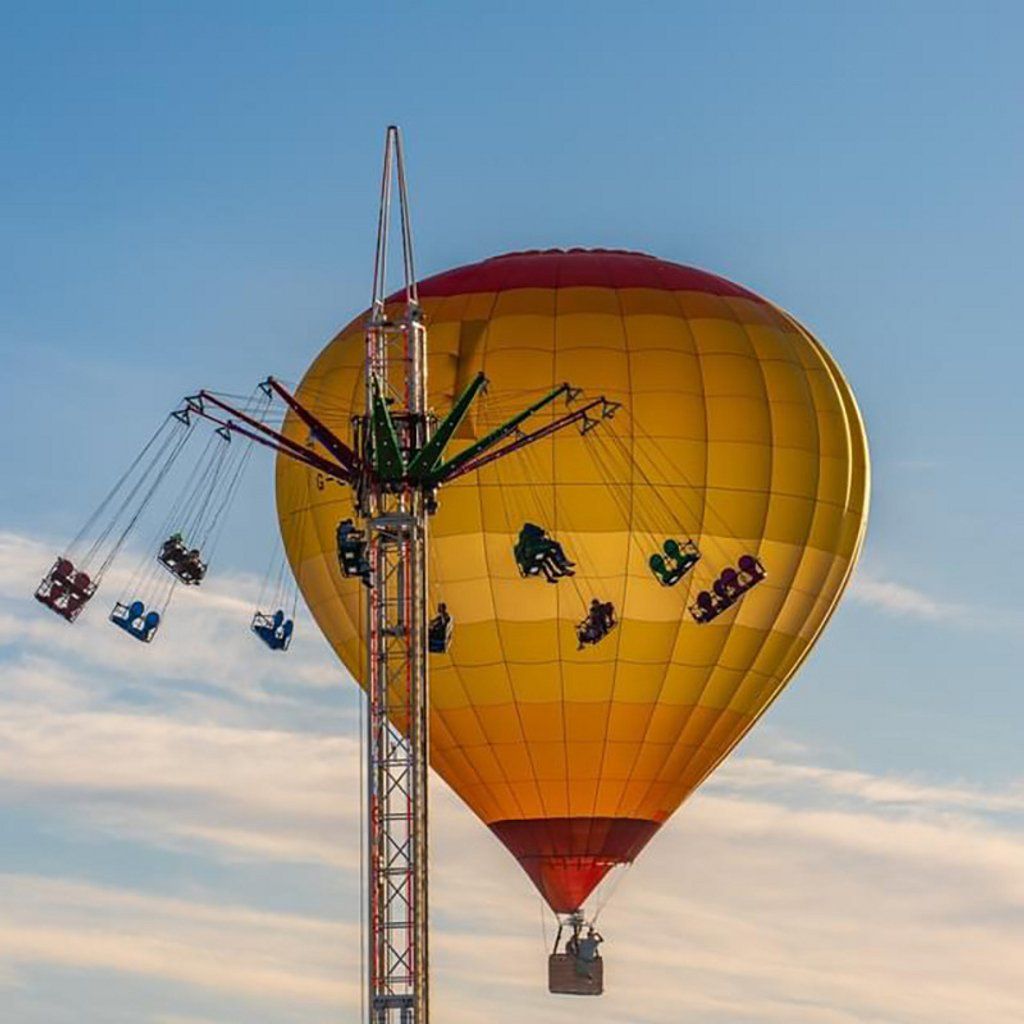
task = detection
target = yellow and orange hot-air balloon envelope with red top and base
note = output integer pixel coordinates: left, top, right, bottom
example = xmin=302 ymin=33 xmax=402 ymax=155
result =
xmin=278 ymin=250 xmax=868 ymax=911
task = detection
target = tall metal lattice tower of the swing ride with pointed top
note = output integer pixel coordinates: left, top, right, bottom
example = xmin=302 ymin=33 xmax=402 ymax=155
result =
xmin=359 ymin=126 xmax=429 ymax=1024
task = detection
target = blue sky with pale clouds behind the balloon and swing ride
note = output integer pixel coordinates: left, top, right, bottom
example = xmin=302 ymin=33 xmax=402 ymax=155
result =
xmin=0 ymin=3 xmax=1024 ymax=1024
